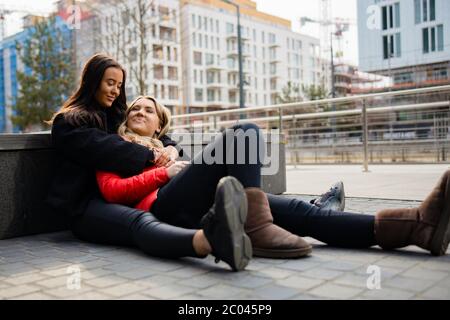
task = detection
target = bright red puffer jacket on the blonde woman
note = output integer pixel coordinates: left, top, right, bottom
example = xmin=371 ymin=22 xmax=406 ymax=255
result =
xmin=96 ymin=166 xmax=170 ymax=211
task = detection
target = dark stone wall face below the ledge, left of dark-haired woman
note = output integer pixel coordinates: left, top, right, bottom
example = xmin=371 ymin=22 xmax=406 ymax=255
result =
xmin=0 ymin=149 xmax=67 ymax=239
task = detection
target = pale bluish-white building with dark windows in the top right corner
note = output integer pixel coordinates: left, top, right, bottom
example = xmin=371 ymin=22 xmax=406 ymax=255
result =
xmin=358 ymin=0 xmax=450 ymax=89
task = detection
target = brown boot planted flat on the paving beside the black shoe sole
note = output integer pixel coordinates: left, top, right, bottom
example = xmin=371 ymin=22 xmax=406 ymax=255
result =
xmin=245 ymin=188 xmax=312 ymax=259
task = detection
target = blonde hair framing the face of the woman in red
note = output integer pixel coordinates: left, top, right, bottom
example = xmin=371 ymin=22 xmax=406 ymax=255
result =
xmin=118 ymin=96 xmax=171 ymax=149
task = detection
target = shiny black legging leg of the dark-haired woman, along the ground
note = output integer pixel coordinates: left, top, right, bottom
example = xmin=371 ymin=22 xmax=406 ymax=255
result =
xmin=71 ymin=198 xmax=197 ymax=258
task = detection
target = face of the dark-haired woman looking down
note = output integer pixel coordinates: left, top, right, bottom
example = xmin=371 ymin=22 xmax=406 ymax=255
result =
xmin=95 ymin=67 xmax=123 ymax=108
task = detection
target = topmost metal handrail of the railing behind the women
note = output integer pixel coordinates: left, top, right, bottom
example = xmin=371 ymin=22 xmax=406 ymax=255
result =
xmin=172 ymin=85 xmax=450 ymax=119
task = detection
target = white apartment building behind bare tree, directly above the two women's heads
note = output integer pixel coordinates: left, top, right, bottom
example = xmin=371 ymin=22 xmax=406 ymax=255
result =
xmin=95 ymin=0 xmax=183 ymax=113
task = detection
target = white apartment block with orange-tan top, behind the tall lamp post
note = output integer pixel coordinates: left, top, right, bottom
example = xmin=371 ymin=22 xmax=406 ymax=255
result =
xmin=180 ymin=0 xmax=323 ymax=112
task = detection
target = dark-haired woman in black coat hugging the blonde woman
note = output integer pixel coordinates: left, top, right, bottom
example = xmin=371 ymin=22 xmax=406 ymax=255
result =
xmin=47 ymin=54 xmax=252 ymax=271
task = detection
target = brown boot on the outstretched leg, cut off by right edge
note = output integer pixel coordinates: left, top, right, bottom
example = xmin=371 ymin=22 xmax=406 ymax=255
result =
xmin=375 ymin=170 xmax=450 ymax=256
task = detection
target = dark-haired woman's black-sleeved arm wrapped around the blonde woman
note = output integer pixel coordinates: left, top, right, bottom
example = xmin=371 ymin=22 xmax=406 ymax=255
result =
xmin=52 ymin=115 xmax=154 ymax=177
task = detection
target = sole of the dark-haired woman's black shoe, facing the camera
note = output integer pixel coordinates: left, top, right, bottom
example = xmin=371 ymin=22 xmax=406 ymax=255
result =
xmin=215 ymin=178 xmax=253 ymax=271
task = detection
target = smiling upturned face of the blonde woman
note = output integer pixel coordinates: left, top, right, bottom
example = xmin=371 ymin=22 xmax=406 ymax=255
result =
xmin=127 ymin=98 xmax=161 ymax=138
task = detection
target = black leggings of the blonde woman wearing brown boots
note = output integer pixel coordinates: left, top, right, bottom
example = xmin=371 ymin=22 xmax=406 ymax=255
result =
xmin=151 ymin=124 xmax=375 ymax=248
